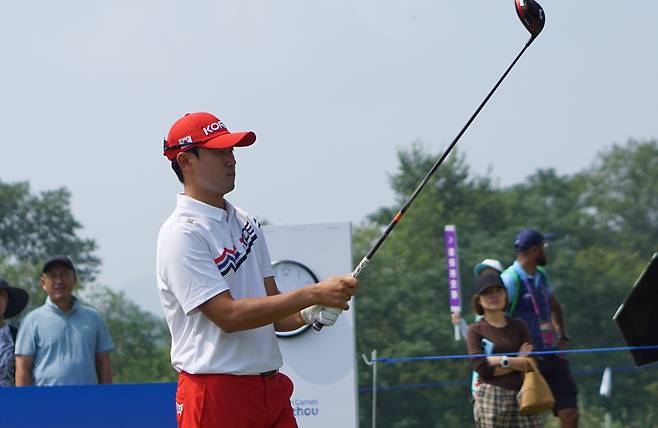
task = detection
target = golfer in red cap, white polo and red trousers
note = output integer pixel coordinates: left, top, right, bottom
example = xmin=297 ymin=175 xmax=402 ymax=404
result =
xmin=157 ymin=113 xmax=357 ymax=428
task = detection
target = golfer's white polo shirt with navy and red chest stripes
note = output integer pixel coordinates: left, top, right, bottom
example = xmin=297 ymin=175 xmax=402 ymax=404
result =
xmin=156 ymin=195 xmax=282 ymax=375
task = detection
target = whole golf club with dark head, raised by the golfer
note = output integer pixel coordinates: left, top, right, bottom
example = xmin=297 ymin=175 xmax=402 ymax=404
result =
xmin=313 ymin=0 xmax=545 ymax=331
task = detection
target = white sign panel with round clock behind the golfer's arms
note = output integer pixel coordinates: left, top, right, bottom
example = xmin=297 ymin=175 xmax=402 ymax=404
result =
xmin=263 ymin=223 xmax=358 ymax=428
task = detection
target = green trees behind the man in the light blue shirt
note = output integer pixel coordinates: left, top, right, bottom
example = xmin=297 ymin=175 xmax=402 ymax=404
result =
xmin=0 ymin=181 xmax=176 ymax=383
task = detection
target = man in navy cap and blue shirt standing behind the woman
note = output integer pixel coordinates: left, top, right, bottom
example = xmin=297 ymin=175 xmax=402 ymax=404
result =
xmin=501 ymin=229 xmax=578 ymax=428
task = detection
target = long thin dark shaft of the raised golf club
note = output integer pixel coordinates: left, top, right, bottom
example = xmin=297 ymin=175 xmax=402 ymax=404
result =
xmin=313 ymin=36 xmax=535 ymax=331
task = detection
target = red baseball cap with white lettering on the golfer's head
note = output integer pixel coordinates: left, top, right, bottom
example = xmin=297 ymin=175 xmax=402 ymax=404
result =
xmin=163 ymin=113 xmax=256 ymax=160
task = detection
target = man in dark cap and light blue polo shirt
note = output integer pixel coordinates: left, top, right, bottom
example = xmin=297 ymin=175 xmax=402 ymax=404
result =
xmin=16 ymin=256 xmax=113 ymax=386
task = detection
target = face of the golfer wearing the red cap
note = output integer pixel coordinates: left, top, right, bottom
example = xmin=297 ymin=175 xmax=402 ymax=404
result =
xmin=195 ymin=148 xmax=235 ymax=195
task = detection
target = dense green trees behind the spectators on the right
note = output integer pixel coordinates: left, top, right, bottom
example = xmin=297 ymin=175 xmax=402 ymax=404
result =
xmin=354 ymin=141 xmax=658 ymax=427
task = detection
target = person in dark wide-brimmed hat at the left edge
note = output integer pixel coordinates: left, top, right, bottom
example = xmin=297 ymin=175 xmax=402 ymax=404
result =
xmin=0 ymin=278 xmax=29 ymax=387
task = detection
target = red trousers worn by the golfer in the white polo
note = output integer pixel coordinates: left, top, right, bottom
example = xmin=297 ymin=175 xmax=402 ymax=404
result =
xmin=176 ymin=372 xmax=297 ymax=428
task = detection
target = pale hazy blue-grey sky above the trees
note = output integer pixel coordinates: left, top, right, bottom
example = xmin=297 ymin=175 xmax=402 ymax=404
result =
xmin=0 ymin=0 xmax=658 ymax=313
